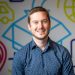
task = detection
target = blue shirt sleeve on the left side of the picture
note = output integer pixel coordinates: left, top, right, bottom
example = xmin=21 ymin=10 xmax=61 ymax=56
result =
xmin=12 ymin=49 xmax=25 ymax=75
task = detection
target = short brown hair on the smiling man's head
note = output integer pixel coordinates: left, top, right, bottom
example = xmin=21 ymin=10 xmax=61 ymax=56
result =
xmin=28 ymin=6 xmax=50 ymax=23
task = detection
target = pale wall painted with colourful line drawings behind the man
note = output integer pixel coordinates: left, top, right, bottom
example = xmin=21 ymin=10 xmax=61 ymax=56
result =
xmin=0 ymin=0 xmax=75 ymax=75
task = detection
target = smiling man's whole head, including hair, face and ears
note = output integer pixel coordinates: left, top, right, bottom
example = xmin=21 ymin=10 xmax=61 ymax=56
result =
xmin=28 ymin=7 xmax=51 ymax=40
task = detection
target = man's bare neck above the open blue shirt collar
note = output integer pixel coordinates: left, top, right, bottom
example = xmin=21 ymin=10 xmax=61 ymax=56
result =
xmin=33 ymin=37 xmax=48 ymax=51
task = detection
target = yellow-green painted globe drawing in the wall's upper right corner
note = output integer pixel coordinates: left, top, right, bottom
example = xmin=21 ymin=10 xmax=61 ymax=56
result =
xmin=64 ymin=0 xmax=75 ymax=22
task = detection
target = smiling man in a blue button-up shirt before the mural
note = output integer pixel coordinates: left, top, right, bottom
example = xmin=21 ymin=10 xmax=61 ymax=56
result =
xmin=12 ymin=7 xmax=74 ymax=75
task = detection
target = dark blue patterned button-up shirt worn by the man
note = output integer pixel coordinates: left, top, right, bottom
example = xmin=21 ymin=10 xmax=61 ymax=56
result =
xmin=12 ymin=39 xmax=74 ymax=75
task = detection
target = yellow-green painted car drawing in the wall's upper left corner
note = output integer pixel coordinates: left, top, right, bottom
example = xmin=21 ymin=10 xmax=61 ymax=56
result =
xmin=0 ymin=1 xmax=15 ymax=24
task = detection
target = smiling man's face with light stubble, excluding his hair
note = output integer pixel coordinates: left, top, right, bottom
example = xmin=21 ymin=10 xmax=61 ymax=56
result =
xmin=28 ymin=11 xmax=50 ymax=40
